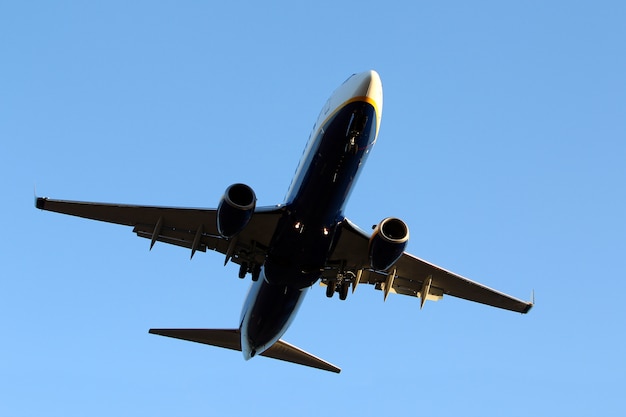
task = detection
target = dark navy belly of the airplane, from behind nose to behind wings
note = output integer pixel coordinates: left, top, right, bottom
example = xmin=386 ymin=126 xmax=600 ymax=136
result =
xmin=265 ymin=102 xmax=376 ymax=288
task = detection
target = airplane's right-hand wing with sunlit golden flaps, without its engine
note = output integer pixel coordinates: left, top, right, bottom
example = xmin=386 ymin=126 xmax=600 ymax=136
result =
xmin=325 ymin=219 xmax=533 ymax=313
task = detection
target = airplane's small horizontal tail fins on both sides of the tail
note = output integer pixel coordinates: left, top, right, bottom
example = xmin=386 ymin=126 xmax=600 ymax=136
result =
xmin=150 ymin=329 xmax=341 ymax=373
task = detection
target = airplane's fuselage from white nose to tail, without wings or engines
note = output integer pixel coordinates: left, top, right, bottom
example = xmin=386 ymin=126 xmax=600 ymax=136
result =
xmin=240 ymin=71 xmax=382 ymax=359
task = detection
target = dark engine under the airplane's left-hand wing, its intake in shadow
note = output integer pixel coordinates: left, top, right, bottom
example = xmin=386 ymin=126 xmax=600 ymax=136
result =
xmin=217 ymin=184 xmax=256 ymax=239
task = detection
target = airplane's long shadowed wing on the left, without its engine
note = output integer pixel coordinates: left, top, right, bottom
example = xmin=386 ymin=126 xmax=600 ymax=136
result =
xmin=36 ymin=198 xmax=281 ymax=263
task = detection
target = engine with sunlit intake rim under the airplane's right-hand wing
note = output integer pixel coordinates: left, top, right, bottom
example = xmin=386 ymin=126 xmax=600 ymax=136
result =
xmin=369 ymin=217 xmax=409 ymax=271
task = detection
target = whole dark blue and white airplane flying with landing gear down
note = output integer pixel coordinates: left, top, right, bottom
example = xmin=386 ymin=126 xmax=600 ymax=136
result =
xmin=35 ymin=70 xmax=534 ymax=373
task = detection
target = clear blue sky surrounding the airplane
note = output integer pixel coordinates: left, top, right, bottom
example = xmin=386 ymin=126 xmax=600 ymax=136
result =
xmin=0 ymin=1 xmax=626 ymax=417
